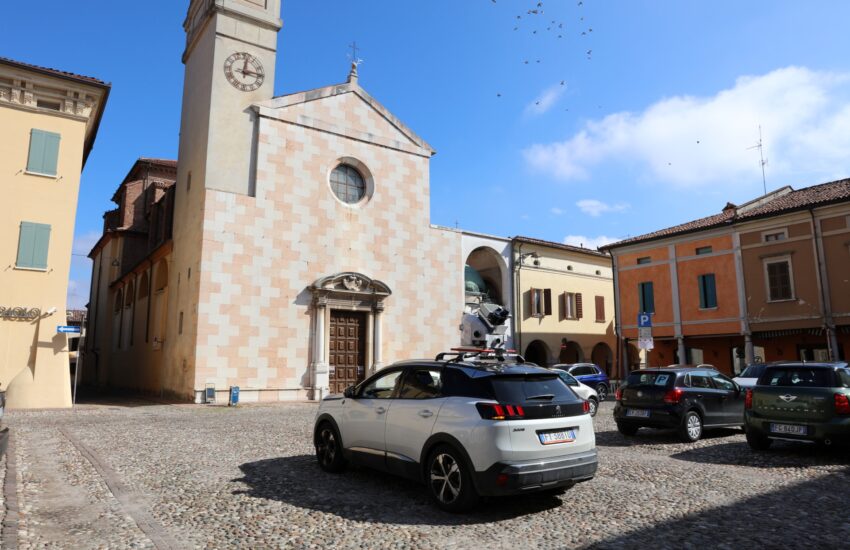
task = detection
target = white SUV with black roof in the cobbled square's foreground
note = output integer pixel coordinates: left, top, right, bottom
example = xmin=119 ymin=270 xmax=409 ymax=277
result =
xmin=314 ymin=355 xmax=597 ymax=512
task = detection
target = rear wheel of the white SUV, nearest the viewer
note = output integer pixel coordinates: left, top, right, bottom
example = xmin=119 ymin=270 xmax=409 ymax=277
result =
xmin=425 ymin=445 xmax=479 ymax=513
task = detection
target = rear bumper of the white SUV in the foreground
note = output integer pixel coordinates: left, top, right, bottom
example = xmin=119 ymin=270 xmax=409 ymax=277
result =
xmin=475 ymin=449 xmax=599 ymax=496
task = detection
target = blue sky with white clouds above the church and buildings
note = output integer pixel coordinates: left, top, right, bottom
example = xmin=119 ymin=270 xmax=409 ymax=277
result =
xmin=0 ymin=0 xmax=850 ymax=305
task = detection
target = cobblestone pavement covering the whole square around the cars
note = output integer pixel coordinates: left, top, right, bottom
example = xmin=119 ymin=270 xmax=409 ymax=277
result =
xmin=0 ymin=402 xmax=850 ymax=549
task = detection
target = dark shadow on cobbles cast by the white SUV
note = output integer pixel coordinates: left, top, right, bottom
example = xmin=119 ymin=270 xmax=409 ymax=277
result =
xmin=234 ymin=455 xmax=570 ymax=528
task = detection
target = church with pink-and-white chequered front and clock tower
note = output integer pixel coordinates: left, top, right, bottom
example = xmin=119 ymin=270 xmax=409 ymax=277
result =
xmin=84 ymin=0 xmax=464 ymax=402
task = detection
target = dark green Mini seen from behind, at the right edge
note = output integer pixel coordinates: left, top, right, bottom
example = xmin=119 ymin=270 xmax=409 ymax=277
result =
xmin=744 ymin=362 xmax=850 ymax=451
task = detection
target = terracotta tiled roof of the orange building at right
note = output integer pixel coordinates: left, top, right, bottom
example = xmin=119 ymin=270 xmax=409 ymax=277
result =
xmin=600 ymin=179 xmax=850 ymax=250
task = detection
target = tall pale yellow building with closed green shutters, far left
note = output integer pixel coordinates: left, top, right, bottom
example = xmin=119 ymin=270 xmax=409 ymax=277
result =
xmin=0 ymin=58 xmax=110 ymax=408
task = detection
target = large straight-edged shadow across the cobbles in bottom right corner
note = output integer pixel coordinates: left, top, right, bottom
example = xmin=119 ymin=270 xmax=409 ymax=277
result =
xmin=590 ymin=469 xmax=850 ymax=549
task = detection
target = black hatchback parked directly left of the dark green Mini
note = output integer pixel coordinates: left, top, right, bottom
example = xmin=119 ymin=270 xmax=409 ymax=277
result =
xmin=614 ymin=367 xmax=744 ymax=442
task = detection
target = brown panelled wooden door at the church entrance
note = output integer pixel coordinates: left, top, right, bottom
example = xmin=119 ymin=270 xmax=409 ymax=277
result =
xmin=329 ymin=310 xmax=368 ymax=393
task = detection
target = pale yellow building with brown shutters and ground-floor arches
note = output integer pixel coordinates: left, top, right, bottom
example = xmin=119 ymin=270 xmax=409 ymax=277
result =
xmin=512 ymin=237 xmax=617 ymax=376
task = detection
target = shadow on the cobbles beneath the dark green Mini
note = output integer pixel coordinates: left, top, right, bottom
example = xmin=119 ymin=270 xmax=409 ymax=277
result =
xmin=670 ymin=441 xmax=850 ymax=468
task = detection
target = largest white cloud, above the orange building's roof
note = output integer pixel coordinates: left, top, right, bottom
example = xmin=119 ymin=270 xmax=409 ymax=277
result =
xmin=524 ymin=67 xmax=850 ymax=187
